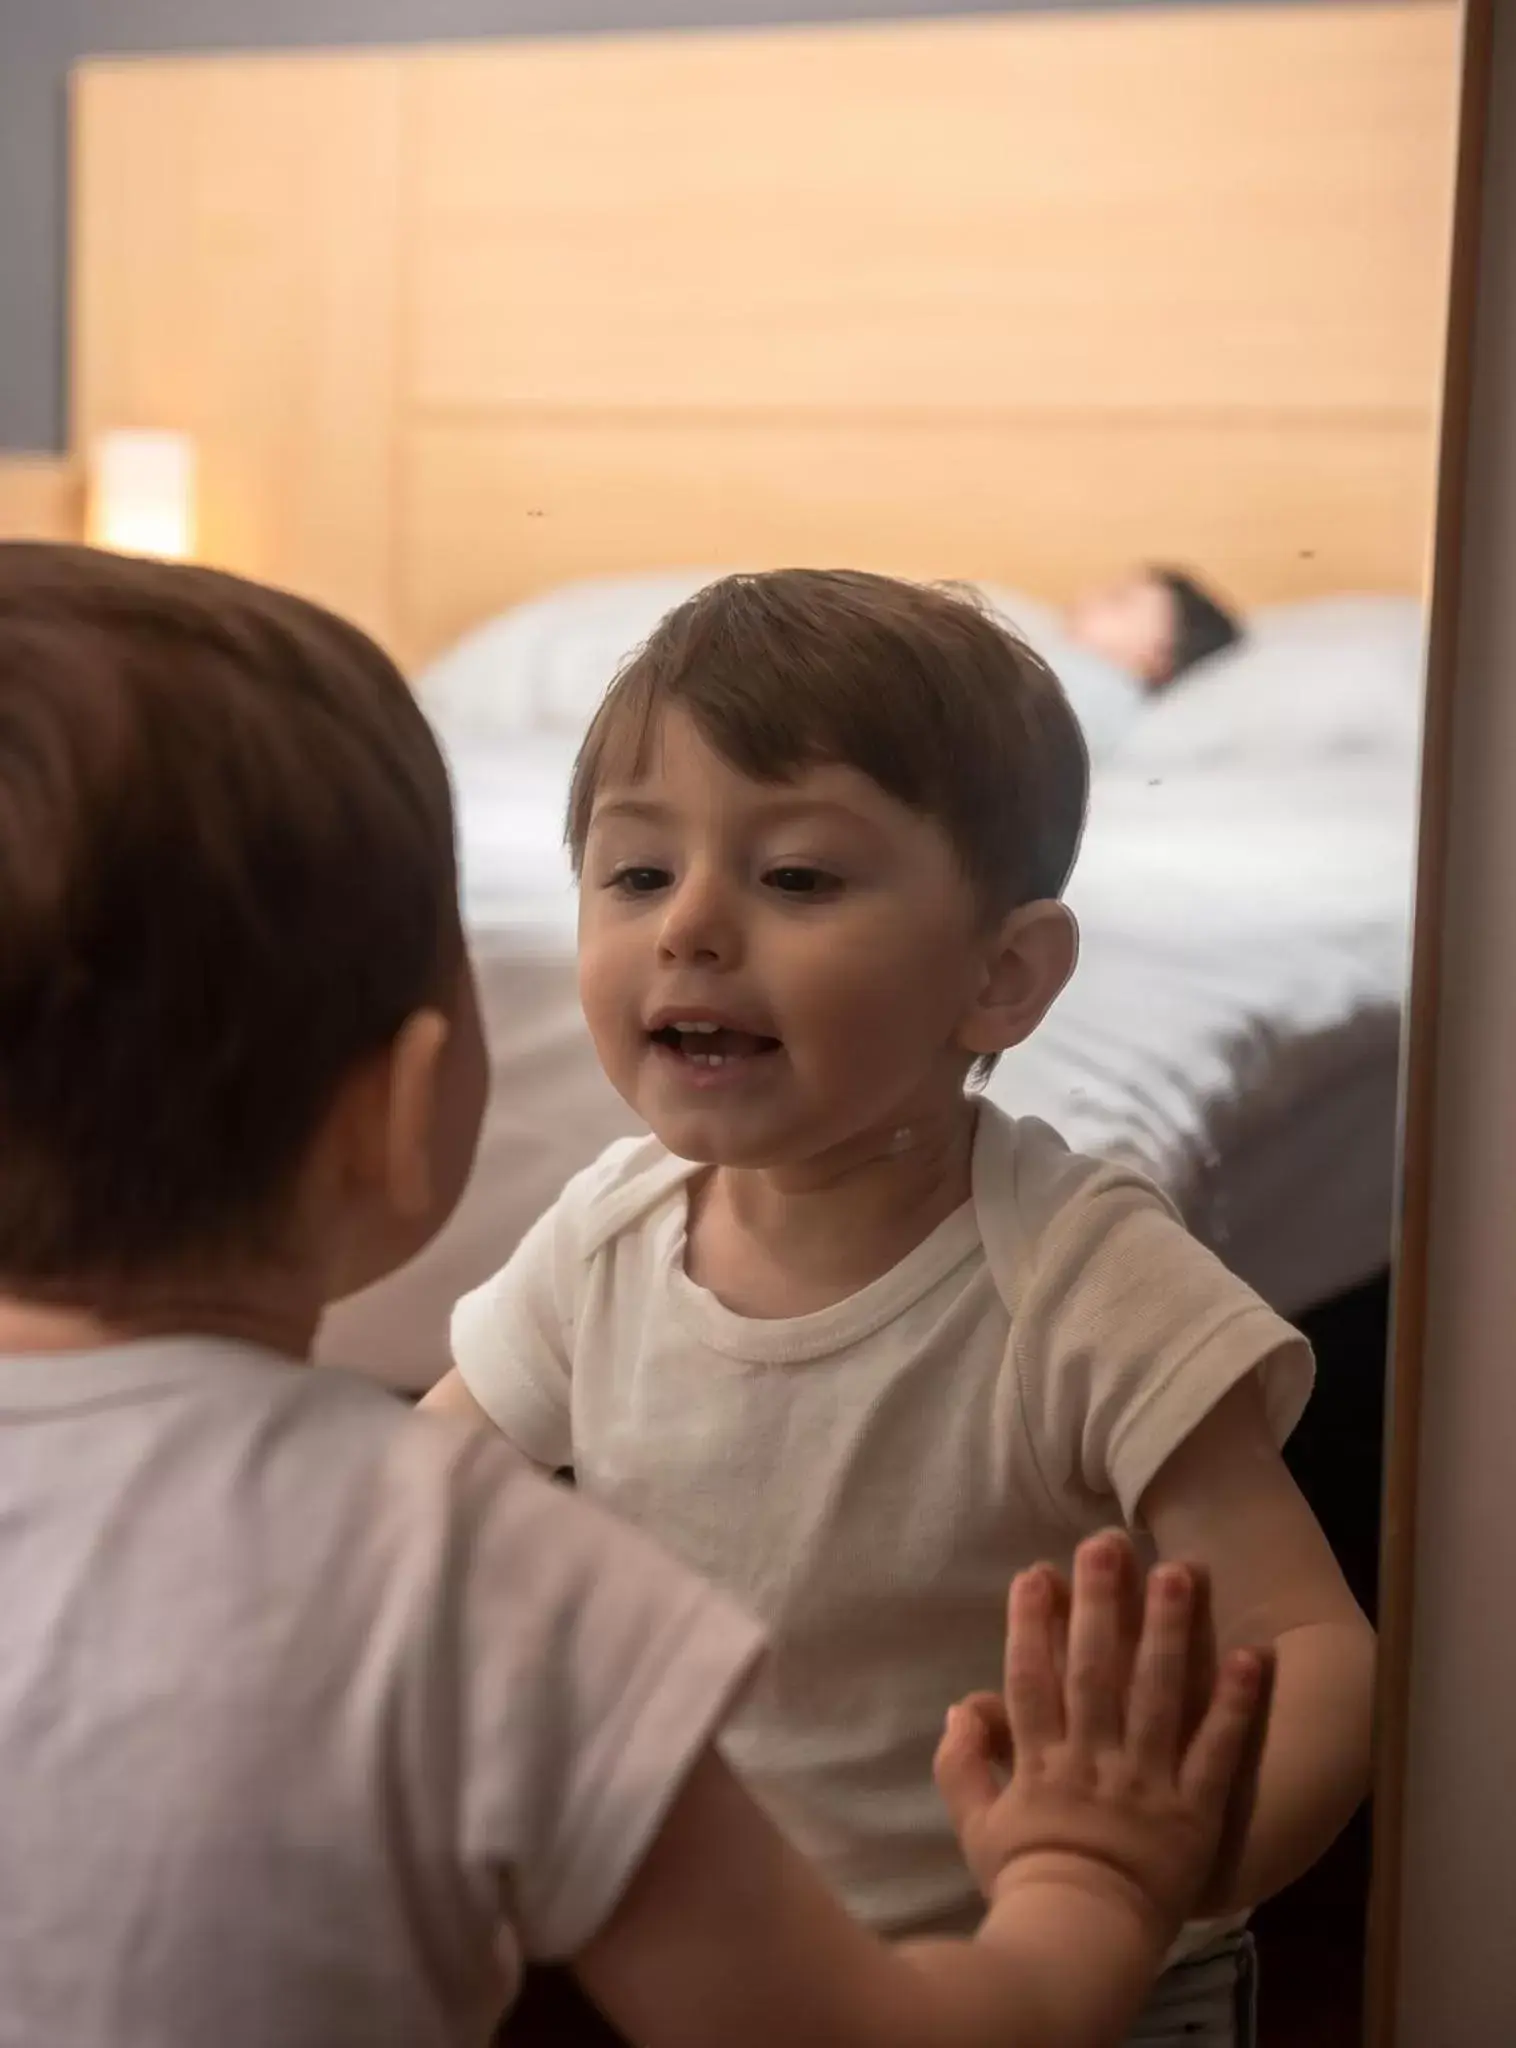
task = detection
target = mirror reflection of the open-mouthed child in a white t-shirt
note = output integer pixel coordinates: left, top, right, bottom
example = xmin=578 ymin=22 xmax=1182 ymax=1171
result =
xmin=430 ymin=571 xmax=1375 ymax=2044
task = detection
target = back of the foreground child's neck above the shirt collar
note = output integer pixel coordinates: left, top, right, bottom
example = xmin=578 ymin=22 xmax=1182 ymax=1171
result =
xmin=0 ymin=1276 xmax=320 ymax=1360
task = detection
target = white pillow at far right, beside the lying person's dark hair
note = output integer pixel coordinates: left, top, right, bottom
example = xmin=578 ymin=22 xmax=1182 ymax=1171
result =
xmin=1119 ymin=598 xmax=1424 ymax=768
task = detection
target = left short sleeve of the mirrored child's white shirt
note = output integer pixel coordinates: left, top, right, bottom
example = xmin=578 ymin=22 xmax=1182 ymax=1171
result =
xmin=451 ymin=1190 xmax=578 ymax=1470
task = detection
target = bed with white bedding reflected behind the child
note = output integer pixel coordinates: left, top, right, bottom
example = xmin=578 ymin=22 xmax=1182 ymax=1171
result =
xmin=322 ymin=573 xmax=1422 ymax=1389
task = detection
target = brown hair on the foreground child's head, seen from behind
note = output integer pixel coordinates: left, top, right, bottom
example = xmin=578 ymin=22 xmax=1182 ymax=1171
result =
xmin=0 ymin=543 xmax=457 ymax=1294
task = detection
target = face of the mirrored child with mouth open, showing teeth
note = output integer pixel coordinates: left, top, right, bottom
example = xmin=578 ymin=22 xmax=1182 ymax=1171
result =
xmin=580 ymin=713 xmax=1012 ymax=1167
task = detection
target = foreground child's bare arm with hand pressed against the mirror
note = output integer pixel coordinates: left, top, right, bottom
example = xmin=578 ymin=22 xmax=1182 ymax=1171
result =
xmin=578 ymin=1538 xmax=1264 ymax=2048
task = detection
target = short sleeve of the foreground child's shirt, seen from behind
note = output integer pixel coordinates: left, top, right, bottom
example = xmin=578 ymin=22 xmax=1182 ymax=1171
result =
xmin=447 ymin=1432 xmax=762 ymax=1962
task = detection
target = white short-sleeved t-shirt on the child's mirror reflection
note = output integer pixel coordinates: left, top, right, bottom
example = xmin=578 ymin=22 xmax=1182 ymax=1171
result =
xmin=453 ymin=1104 xmax=1311 ymax=1933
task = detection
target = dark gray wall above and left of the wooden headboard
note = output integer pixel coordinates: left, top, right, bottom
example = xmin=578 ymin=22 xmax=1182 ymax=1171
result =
xmin=0 ymin=0 xmax=1352 ymax=449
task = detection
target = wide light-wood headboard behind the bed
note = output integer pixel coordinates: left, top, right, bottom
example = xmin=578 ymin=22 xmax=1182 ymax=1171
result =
xmin=72 ymin=0 xmax=1459 ymax=659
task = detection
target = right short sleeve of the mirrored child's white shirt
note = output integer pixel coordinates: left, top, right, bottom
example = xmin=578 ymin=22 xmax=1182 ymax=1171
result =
xmin=1012 ymin=1159 xmax=1313 ymax=1524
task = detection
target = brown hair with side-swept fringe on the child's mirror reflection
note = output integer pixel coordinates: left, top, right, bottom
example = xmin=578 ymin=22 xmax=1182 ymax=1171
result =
xmin=567 ymin=569 xmax=1090 ymax=918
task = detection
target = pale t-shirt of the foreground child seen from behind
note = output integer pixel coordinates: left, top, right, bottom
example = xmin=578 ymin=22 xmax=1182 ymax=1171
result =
xmin=0 ymin=1339 xmax=758 ymax=2048
